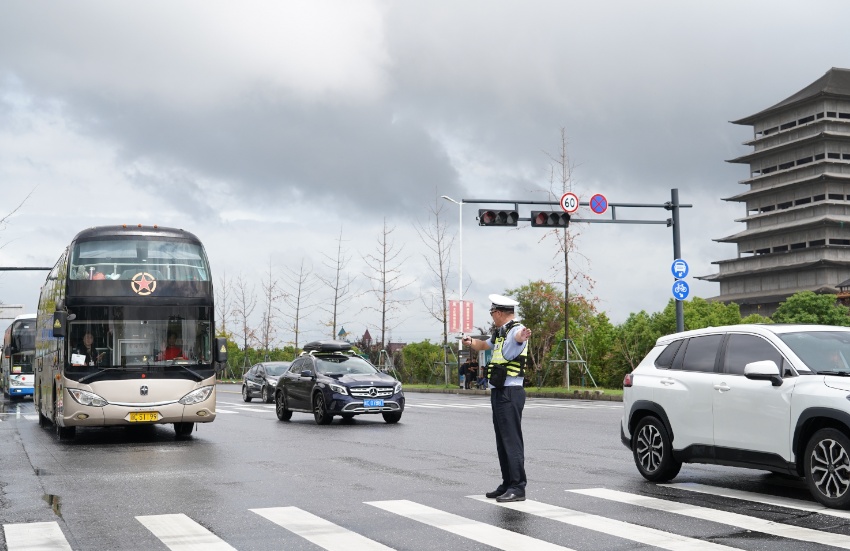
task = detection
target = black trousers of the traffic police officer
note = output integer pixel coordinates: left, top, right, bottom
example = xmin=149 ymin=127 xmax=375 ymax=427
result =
xmin=490 ymin=386 xmax=526 ymax=494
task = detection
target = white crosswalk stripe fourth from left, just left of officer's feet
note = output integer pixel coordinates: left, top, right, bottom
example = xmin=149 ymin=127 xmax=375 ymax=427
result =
xmin=365 ymin=499 xmax=572 ymax=551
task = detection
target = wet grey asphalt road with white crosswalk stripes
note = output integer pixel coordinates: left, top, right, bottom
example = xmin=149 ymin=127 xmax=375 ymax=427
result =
xmin=0 ymin=385 xmax=850 ymax=551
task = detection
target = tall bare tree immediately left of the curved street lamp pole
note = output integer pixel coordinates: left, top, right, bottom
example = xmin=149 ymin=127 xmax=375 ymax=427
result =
xmin=414 ymin=198 xmax=454 ymax=346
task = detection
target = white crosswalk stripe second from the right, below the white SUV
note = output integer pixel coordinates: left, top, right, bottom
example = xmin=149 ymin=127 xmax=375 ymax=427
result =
xmin=567 ymin=488 xmax=850 ymax=549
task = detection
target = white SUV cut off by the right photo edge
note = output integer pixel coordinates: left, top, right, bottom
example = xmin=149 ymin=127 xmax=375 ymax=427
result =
xmin=620 ymin=325 xmax=850 ymax=508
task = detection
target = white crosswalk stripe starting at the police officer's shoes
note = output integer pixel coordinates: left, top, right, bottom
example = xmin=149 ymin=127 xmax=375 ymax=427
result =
xmin=466 ymin=496 xmax=738 ymax=551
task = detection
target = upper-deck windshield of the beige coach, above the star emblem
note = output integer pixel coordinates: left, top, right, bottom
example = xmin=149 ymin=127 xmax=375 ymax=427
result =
xmin=69 ymin=237 xmax=210 ymax=281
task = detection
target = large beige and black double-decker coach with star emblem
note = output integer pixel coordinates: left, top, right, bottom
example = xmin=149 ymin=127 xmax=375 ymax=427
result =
xmin=33 ymin=225 xmax=227 ymax=440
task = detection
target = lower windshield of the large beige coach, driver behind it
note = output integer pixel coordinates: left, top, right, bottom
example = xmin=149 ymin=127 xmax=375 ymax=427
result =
xmin=65 ymin=306 xmax=213 ymax=381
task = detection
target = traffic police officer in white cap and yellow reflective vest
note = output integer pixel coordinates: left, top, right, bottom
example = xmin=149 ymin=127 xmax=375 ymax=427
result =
xmin=463 ymin=295 xmax=531 ymax=503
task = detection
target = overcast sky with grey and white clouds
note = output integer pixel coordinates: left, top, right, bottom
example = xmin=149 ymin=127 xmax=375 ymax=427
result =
xmin=0 ymin=0 xmax=850 ymax=342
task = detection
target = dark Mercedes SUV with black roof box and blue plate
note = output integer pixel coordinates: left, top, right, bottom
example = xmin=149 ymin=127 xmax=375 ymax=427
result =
xmin=274 ymin=341 xmax=404 ymax=425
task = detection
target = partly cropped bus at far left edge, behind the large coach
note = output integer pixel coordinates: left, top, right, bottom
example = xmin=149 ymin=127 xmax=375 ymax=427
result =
xmin=0 ymin=314 xmax=35 ymax=400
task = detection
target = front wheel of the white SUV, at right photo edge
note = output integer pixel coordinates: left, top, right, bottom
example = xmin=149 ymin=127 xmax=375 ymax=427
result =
xmin=803 ymin=429 xmax=850 ymax=509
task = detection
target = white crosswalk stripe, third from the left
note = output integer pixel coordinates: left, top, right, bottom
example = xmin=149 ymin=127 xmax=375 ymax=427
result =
xmin=251 ymin=507 xmax=392 ymax=551
